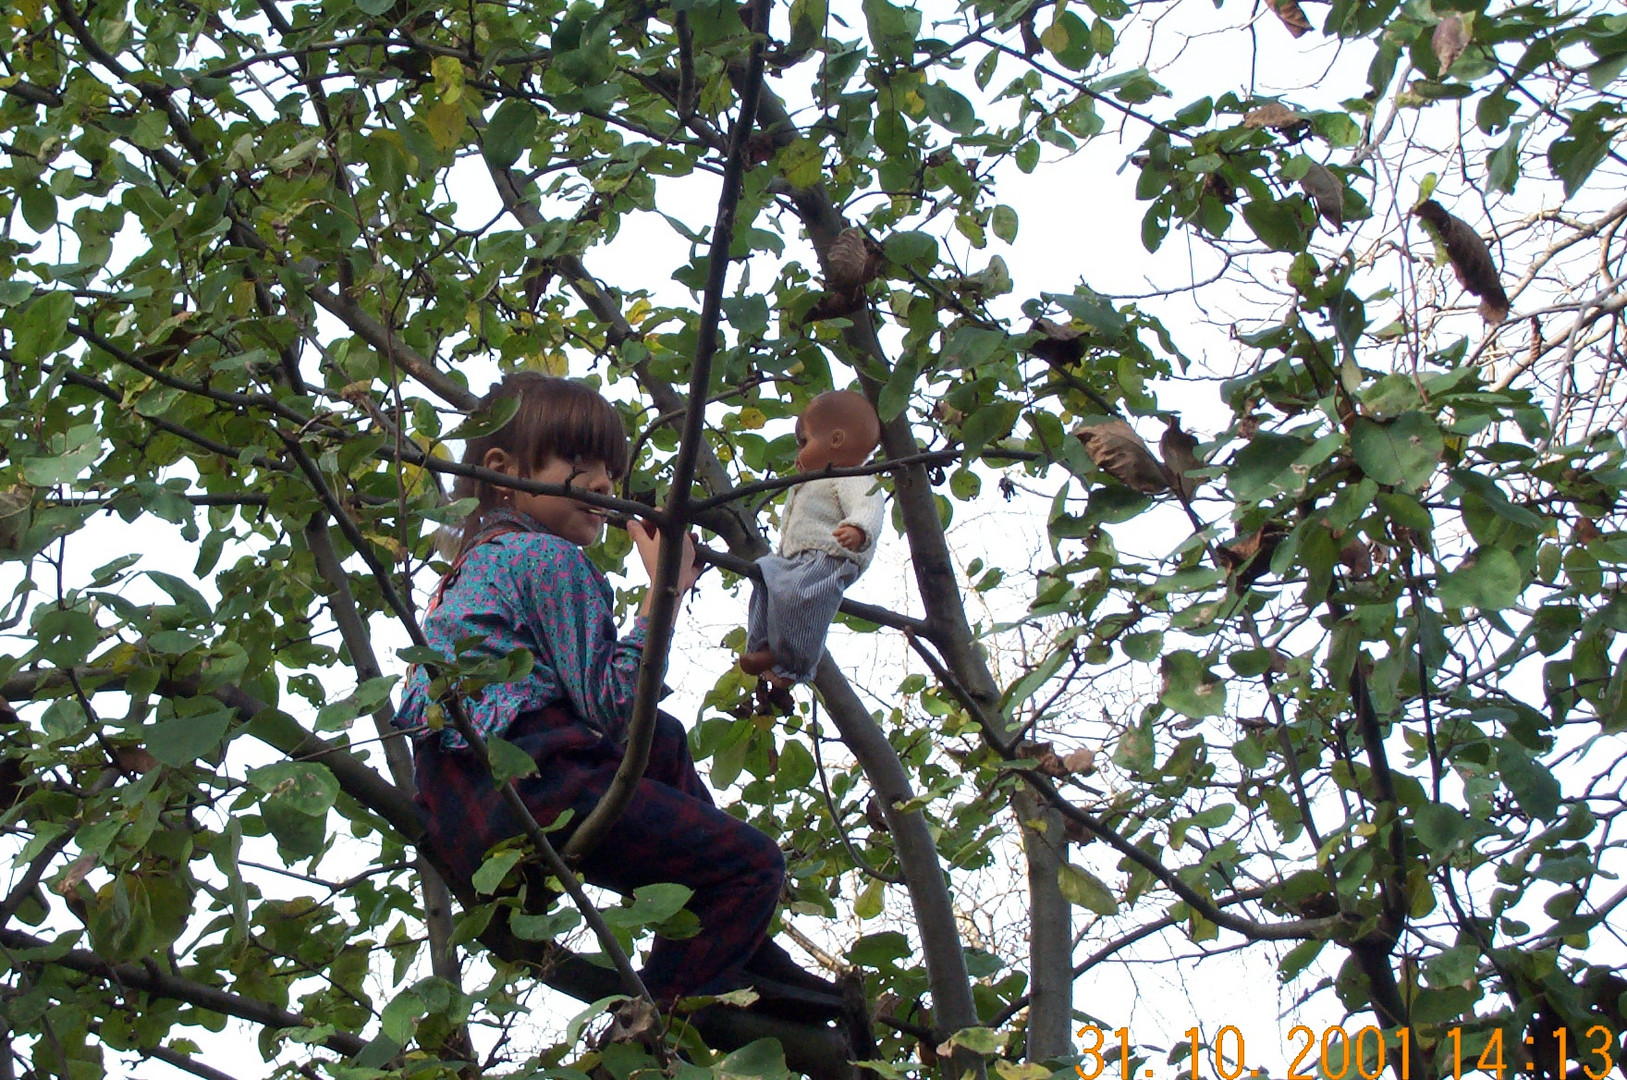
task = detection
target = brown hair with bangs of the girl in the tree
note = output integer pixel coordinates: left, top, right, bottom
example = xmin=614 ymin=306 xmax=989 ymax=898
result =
xmin=452 ymin=371 xmax=628 ymax=548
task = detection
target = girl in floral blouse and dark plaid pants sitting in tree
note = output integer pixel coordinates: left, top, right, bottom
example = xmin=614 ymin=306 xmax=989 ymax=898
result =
xmin=397 ymin=372 xmax=813 ymax=1005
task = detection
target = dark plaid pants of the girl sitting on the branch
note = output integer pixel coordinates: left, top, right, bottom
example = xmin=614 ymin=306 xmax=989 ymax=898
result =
xmin=417 ymin=706 xmax=780 ymax=1002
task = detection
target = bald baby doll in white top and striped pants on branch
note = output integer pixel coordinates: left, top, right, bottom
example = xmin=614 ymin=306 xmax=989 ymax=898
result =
xmin=740 ymin=390 xmax=882 ymax=688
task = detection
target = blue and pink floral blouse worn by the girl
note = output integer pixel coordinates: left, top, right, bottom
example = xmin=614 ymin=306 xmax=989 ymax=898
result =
xmin=395 ymin=509 xmax=648 ymax=747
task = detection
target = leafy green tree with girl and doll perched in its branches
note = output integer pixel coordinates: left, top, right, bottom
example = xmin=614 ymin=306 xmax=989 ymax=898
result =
xmin=0 ymin=0 xmax=1627 ymax=1080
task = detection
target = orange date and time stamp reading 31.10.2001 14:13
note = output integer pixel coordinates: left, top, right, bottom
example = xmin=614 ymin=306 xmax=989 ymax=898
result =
xmin=1074 ymin=1023 xmax=1616 ymax=1080
